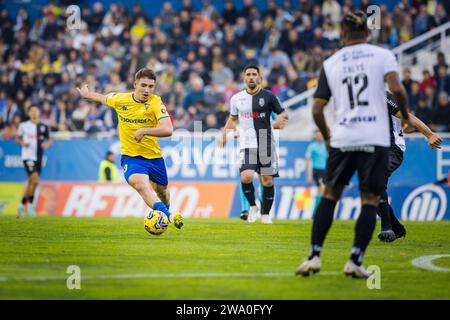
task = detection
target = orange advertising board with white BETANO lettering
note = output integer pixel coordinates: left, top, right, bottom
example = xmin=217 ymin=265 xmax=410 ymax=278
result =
xmin=31 ymin=182 xmax=235 ymax=218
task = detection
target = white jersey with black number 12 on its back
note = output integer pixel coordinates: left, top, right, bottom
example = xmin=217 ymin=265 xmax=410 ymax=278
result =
xmin=314 ymin=44 xmax=398 ymax=148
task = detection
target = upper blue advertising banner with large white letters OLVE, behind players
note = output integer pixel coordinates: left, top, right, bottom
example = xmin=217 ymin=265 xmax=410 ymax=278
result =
xmin=0 ymin=138 xmax=444 ymax=187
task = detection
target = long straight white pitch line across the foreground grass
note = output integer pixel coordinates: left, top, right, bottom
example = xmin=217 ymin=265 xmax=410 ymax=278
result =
xmin=0 ymin=270 xmax=425 ymax=282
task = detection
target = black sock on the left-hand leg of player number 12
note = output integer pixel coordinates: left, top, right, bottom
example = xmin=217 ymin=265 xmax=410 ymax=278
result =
xmin=308 ymin=198 xmax=337 ymax=259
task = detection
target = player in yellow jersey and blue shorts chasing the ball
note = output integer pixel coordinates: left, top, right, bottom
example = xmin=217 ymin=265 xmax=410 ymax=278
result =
xmin=77 ymin=68 xmax=183 ymax=229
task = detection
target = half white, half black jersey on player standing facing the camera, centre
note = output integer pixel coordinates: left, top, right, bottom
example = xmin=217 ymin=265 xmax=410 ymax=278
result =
xmin=230 ymin=89 xmax=284 ymax=149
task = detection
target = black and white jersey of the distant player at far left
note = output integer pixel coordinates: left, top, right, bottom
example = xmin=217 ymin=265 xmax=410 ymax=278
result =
xmin=18 ymin=120 xmax=50 ymax=161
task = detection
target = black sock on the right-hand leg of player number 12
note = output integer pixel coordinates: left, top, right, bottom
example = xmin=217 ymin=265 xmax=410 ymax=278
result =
xmin=350 ymin=204 xmax=377 ymax=266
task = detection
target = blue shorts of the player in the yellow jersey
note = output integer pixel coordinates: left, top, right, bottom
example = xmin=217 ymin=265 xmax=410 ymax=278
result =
xmin=120 ymin=155 xmax=169 ymax=186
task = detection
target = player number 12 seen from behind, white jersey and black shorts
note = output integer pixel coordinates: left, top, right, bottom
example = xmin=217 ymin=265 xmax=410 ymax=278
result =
xmin=295 ymin=11 xmax=410 ymax=278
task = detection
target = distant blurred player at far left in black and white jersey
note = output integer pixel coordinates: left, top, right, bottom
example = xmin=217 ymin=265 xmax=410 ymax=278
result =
xmin=16 ymin=105 xmax=53 ymax=217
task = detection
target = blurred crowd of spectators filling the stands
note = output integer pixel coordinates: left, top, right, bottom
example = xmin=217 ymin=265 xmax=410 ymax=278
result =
xmin=0 ymin=0 xmax=450 ymax=138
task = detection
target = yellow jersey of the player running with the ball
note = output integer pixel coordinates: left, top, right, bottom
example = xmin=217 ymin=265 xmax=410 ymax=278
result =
xmin=106 ymin=92 xmax=169 ymax=159
